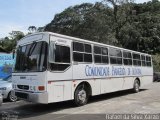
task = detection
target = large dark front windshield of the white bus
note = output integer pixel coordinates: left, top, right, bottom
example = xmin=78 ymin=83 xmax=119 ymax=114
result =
xmin=15 ymin=41 xmax=48 ymax=72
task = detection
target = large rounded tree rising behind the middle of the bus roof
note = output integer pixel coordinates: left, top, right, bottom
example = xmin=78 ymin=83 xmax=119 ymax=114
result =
xmin=45 ymin=2 xmax=117 ymax=44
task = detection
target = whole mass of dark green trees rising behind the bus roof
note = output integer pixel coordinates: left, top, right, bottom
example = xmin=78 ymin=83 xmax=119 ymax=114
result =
xmin=45 ymin=0 xmax=160 ymax=53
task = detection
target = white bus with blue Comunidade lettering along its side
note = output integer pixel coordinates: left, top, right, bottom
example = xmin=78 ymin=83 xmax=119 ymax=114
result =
xmin=12 ymin=32 xmax=153 ymax=106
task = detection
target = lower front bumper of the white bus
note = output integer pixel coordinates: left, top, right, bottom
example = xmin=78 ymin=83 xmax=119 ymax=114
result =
xmin=13 ymin=90 xmax=48 ymax=104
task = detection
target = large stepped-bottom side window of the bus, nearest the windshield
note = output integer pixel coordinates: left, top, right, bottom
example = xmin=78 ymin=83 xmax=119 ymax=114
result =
xmin=50 ymin=45 xmax=70 ymax=71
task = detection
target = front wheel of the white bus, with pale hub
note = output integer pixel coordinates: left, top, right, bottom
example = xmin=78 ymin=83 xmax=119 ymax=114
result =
xmin=74 ymin=84 xmax=88 ymax=106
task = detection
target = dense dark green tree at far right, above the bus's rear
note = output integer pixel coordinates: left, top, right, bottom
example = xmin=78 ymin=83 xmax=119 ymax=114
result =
xmin=120 ymin=1 xmax=160 ymax=53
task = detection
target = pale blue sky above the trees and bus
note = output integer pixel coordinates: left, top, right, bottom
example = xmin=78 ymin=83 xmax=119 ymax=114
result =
xmin=0 ymin=0 xmax=150 ymax=38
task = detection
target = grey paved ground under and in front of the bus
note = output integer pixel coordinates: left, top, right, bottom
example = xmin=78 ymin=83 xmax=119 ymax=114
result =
xmin=0 ymin=82 xmax=160 ymax=120
